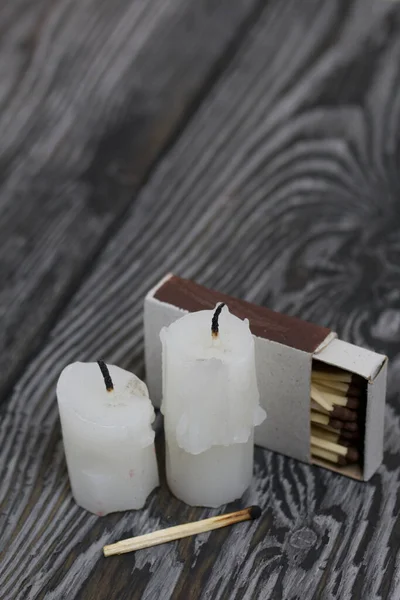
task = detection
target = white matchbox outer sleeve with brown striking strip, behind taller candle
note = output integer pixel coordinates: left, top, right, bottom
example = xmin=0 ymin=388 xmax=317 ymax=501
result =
xmin=144 ymin=275 xmax=334 ymax=462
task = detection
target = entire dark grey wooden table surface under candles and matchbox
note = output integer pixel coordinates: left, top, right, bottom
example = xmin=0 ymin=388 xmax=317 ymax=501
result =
xmin=0 ymin=0 xmax=400 ymax=600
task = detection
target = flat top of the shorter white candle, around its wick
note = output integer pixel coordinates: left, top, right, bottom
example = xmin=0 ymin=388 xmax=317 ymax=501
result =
xmin=57 ymin=362 xmax=154 ymax=431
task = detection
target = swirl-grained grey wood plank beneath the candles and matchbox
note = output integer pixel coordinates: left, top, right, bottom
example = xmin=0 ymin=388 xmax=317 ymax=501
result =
xmin=0 ymin=0 xmax=400 ymax=600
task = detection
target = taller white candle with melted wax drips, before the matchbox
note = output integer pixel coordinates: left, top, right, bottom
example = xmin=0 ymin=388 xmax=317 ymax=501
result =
xmin=161 ymin=306 xmax=266 ymax=507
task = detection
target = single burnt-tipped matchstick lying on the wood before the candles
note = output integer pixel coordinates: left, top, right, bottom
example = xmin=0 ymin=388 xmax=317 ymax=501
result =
xmin=103 ymin=506 xmax=261 ymax=556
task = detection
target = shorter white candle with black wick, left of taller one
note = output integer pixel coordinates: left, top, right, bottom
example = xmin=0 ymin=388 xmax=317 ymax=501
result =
xmin=57 ymin=362 xmax=159 ymax=516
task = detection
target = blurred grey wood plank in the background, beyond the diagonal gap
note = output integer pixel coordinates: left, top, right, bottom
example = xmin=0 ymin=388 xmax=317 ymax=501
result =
xmin=0 ymin=0 xmax=262 ymax=404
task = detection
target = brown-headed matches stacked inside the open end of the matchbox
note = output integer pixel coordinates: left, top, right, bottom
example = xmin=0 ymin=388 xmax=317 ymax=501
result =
xmin=310 ymin=359 xmax=367 ymax=473
